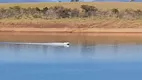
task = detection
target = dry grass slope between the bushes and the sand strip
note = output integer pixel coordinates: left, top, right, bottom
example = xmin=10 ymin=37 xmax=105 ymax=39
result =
xmin=0 ymin=18 xmax=142 ymax=28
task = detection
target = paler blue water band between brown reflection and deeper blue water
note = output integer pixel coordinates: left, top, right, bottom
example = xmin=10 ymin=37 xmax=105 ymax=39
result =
xmin=0 ymin=44 xmax=142 ymax=62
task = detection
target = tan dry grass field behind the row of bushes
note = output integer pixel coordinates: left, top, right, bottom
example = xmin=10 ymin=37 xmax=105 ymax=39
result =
xmin=0 ymin=2 xmax=142 ymax=10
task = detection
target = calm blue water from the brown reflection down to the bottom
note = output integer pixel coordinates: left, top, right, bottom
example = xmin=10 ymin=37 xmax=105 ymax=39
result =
xmin=0 ymin=44 xmax=142 ymax=80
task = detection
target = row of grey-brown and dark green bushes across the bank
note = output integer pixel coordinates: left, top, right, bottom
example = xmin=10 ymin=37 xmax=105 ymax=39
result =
xmin=0 ymin=5 xmax=142 ymax=19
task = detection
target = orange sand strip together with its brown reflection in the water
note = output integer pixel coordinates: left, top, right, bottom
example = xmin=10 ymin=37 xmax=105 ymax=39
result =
xmin=0 ymin=28 xmax=142 ymax=44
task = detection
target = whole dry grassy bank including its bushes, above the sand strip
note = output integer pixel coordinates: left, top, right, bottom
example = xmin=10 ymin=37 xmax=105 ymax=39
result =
xmin=0 ymin=2 xmax=142 ymax=28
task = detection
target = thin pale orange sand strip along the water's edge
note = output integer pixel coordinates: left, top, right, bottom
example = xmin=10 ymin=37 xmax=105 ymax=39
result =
xmin=0 ymin=28 xmax=142 ymax=34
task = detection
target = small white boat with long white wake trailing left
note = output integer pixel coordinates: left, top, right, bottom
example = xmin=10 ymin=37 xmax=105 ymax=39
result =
xmin=0 ymin=42 xmax=70 ymax=47
